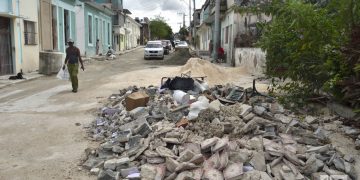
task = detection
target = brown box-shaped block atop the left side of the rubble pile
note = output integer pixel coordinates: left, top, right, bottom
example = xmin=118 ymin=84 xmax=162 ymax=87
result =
xmin=125 ymin=91 xmax=149 ymax=111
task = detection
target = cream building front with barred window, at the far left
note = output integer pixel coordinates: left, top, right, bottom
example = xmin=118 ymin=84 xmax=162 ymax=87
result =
xmin=0 ymin=0 xmax=39 ymax=75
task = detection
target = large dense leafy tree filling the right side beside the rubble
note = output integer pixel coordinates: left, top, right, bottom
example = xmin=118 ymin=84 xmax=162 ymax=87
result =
xmin=234 ymin=0 xmax=360 ymax=108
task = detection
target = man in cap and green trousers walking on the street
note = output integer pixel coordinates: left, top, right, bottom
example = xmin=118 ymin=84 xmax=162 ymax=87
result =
xmin=63 ymin=39 xmax=85 ymax=93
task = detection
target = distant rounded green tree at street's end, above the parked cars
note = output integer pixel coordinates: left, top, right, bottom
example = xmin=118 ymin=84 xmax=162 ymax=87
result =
xmin=150 ymin=15 xmax=173 ymax=40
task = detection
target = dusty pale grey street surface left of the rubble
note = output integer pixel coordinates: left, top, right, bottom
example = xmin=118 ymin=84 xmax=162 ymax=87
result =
xmin=0 ymin=48 xmax=187 ymax=179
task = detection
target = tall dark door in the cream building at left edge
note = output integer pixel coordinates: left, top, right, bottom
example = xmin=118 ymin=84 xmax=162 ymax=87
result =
xmin=0 ymin=17 xmax=14 ymax=75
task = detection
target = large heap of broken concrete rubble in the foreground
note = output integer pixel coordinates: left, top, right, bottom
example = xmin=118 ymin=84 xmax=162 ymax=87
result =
xmin=83 ymin=76 xmax=360 ymax=180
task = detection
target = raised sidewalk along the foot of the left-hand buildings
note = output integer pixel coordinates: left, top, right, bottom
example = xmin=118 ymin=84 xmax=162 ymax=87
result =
xmin=0 ymin=46 xmax=143 ymax=89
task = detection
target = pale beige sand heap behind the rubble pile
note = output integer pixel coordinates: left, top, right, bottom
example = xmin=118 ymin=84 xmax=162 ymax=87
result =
xmin=179 ymin=58 xmax=231 ymax=82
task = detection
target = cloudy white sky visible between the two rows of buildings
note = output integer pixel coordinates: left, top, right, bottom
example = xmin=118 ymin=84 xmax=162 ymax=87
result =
xmin=123 ymin=0 xmax=205 ymax=33
